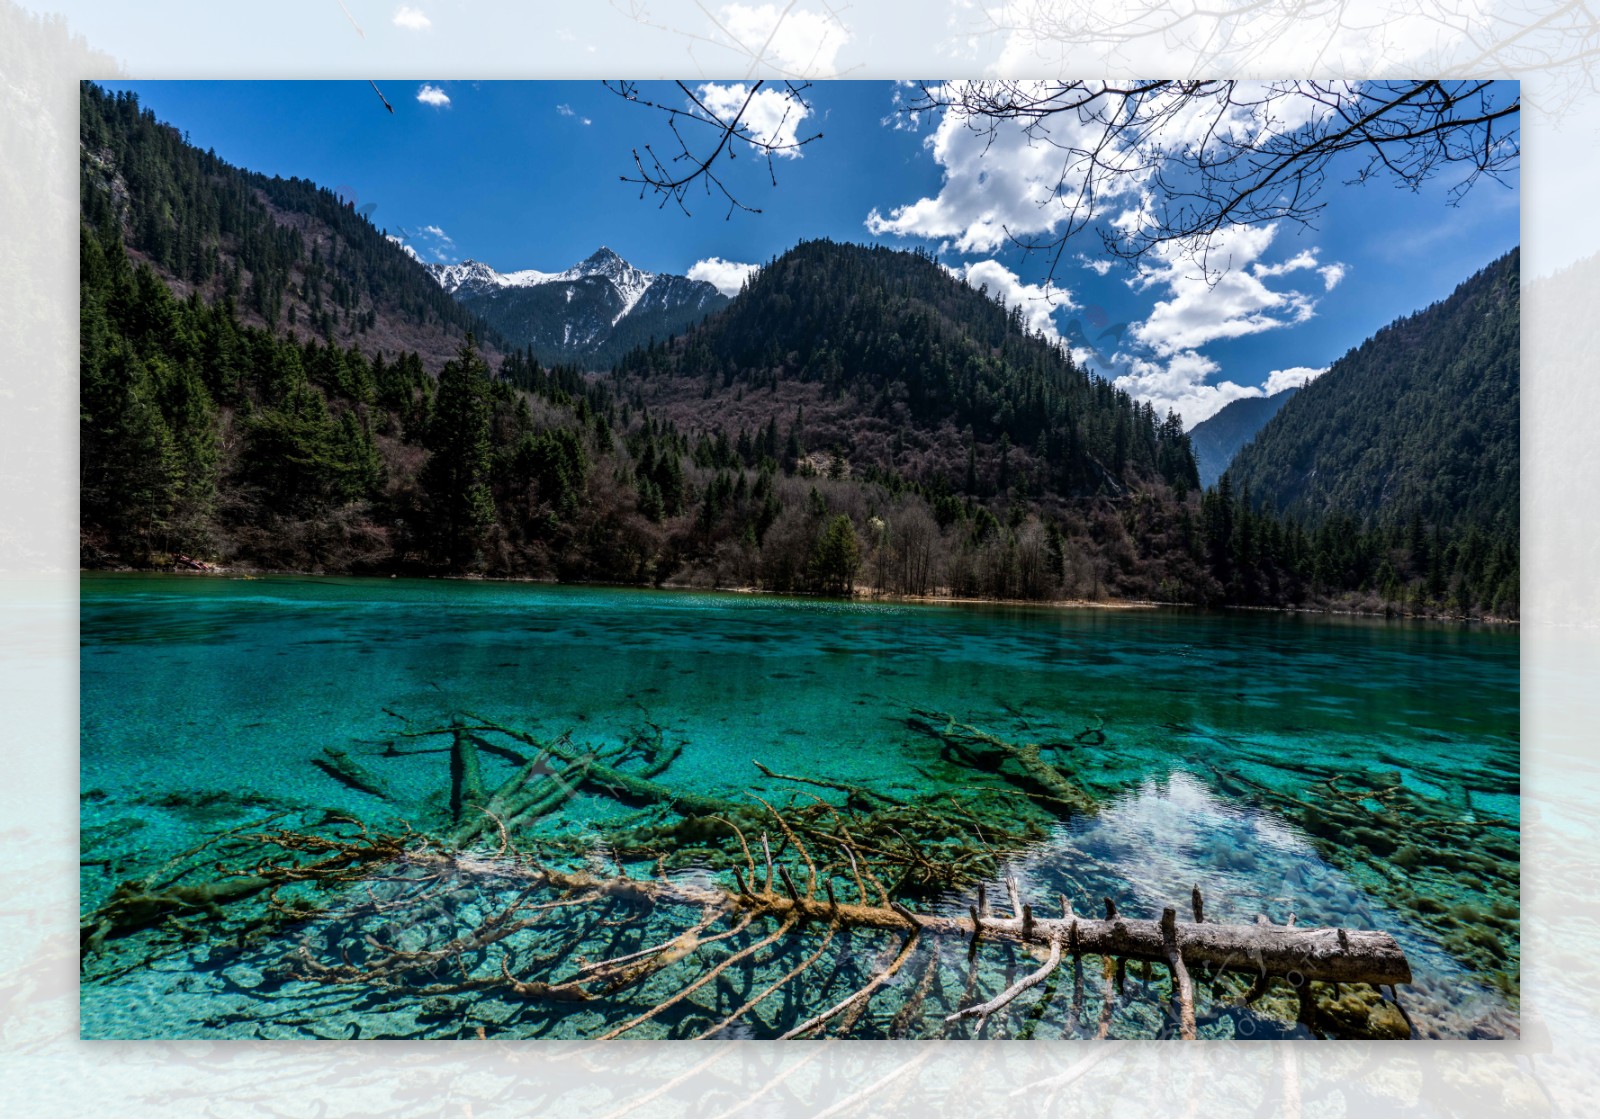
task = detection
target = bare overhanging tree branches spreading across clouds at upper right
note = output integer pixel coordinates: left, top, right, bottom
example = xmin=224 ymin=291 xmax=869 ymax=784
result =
xmin=901 ymin=80 xmax=1522 ymax=274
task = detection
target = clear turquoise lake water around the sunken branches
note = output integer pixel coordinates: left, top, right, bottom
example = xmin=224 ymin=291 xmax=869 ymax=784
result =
xmin=80 ymin=574 xmax=1520 ymax=1038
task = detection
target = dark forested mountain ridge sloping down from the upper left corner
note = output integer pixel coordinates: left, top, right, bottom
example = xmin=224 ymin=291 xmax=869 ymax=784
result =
xmin=78 ymin=82 xmax=499 ymax=371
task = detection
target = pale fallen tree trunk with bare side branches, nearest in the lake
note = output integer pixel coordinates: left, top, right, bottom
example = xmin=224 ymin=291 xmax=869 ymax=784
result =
xmin=249 ymin=832 xmax=1411 ymax=1038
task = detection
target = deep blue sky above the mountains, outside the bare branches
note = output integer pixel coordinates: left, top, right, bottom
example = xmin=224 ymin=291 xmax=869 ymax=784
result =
xmin=109 ymin=78 xmax=1520 ymax=424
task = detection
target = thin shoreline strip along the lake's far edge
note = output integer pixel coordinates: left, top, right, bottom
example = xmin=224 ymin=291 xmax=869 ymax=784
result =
xmin=78 ymin=566 xmax=1522 ymax=626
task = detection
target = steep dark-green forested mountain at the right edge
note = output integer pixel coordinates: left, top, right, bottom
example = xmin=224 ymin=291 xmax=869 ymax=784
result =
xmin=1230 ymin=250 xmax=1520 ymax=536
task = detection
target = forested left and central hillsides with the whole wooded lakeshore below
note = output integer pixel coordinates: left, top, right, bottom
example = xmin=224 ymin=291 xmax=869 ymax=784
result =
xmin=80 ymin=86 xmax=1517 ymax=614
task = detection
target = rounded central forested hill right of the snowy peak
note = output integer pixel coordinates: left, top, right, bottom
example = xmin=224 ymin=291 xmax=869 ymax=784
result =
xmin=614 ymin=240 xmax=1198 ymax=498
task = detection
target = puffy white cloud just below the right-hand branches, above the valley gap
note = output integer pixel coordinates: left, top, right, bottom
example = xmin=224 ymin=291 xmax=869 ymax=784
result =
xmin=1128 ymin=224 xmax=1317 ymax=357
